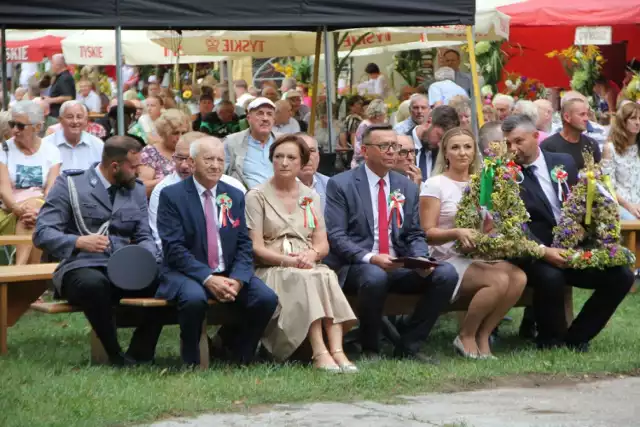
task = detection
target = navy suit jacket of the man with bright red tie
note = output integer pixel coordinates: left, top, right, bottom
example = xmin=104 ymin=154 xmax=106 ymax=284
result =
xmin=325 ymin=165 xmax=429 ymax=284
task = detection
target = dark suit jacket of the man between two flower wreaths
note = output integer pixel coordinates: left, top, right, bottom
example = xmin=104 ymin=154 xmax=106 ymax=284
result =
xmin=520 ymin=150 xmax=578 ymax=246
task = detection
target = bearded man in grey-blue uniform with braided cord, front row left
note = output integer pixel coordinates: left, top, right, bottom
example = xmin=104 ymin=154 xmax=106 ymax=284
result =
xmin=33 ymin=136 xmax=162 ymax=366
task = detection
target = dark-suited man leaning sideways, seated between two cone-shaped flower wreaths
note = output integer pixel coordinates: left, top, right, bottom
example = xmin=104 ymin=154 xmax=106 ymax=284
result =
xmin=502 ymin=115 xmax=634 ymax=352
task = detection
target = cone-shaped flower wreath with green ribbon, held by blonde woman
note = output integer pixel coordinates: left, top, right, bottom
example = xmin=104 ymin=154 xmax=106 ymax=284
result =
xmin=456 ymin=141 xmax=543 ymax=260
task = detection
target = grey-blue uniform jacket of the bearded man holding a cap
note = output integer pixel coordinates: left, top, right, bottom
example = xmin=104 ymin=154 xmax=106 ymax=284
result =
xmin=33 ymin=165 xmax=159 ymax=291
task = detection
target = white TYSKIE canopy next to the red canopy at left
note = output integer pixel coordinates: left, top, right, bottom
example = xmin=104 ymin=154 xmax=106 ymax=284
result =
xmin=62 ymin=30 xmax=225 ymax=65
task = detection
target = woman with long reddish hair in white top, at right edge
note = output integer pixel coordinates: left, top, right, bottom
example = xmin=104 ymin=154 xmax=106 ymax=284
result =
xmin=602 ymin=102 xmax=640 ymax=220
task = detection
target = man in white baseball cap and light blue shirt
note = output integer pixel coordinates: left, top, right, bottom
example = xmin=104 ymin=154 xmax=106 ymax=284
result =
xmin=224 ymin=97 xmax=278 ymax=189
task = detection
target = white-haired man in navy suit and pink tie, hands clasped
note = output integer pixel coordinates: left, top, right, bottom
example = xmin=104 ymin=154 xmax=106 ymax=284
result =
xmin=157 ymin=137 xmax=278 ymax=365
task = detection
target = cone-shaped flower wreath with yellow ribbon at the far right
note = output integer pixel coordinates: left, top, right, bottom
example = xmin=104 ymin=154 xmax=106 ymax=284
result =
xmin=553 ymin=153 xmax=636 ymax=269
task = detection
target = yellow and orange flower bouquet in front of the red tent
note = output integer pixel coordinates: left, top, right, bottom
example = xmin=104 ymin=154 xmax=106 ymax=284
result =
xmin=547 ymin=45 xmax=606 ymax=96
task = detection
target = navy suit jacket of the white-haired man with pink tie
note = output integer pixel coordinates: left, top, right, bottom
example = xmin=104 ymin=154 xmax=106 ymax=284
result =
xmin=158 ymin=177 xmax=253 ymax=299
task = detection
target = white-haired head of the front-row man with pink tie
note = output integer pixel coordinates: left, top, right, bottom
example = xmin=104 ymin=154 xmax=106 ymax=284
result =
xmin=189 ymin=136 xmax=224 ymax=190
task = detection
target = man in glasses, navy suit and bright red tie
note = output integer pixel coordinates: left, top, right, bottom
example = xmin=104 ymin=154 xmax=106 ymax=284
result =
xmin=325 ymin=126 xmax=458 ymax=361
